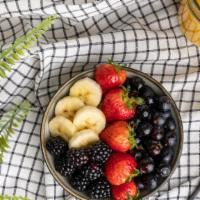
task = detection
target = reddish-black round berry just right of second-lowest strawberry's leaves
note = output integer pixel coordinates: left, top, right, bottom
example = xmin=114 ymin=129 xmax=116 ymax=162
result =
xmin=138 ymin=157 xmax=154 ymax=174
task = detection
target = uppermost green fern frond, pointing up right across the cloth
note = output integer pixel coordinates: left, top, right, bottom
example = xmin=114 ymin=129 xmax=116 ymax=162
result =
xmin=0 ymin=16 xmax=57 ymax=78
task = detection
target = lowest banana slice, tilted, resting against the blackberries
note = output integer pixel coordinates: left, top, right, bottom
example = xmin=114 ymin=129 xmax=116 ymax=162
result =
xmin=69 ymin=129 xmax=99 ymax=148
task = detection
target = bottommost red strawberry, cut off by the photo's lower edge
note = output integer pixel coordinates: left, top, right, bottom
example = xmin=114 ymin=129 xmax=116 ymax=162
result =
xmin=112 ymin=181 xmax=138 ymax=200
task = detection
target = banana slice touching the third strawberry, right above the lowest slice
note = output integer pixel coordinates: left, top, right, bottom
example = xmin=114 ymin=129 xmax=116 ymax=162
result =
xmin=73 ymin=106 xmax=106 ymax=134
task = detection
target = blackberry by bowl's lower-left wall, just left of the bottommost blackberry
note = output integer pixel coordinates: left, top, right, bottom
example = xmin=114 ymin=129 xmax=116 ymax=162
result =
xmin=70 ymin=174 xmax=89 ymax=192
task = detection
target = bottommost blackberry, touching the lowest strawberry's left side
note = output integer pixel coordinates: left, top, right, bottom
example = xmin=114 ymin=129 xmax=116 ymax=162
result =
xmin=87 ymin=178 xmax=111 ymax=199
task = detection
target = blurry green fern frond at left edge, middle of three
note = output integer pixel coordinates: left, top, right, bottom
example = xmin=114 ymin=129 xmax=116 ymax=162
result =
xmin=0 ymin=101 xmax=30 ymax=164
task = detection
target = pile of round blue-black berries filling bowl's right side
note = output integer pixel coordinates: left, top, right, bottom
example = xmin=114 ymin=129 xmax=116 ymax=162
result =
xmin=124 ymin=76 xmax=178 ymax=195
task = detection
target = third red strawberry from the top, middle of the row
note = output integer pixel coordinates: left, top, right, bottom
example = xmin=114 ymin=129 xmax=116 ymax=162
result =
xmin=100 ymin=121 xmax=136 ymax=152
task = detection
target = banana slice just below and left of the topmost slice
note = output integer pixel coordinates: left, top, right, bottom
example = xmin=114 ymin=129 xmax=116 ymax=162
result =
xmin=55 ymin=96 xmax=84 ymax=120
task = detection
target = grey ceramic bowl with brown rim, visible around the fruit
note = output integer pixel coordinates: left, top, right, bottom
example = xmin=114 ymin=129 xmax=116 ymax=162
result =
xmin=40 ymin=68 xmax=183 ymax=200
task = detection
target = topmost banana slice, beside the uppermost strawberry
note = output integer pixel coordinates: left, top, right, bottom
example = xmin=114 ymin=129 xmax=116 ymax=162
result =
xmin=69 ymin=78 xmax=102 ymax=106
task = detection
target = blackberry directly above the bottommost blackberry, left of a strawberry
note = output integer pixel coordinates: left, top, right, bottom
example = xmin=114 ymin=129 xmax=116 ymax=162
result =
xmin=80 ymin=163 xmax=103 ymax=181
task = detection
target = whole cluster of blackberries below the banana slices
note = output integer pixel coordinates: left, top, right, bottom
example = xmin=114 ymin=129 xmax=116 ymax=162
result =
xmin=46 ymin=137 xmax=112 ymax=199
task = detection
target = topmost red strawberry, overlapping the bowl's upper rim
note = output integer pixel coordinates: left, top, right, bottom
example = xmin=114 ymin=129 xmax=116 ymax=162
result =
xmin=95 ymin=63 xmax=126 ymax=92
